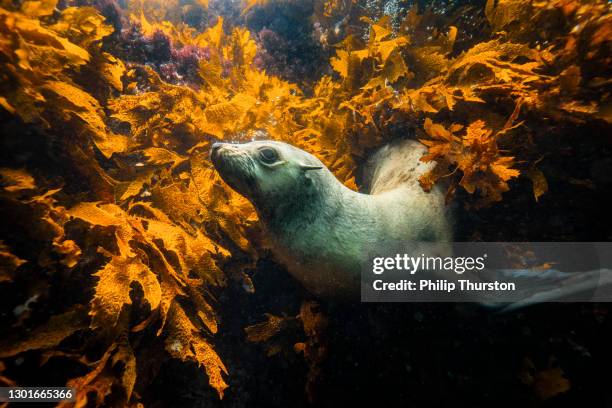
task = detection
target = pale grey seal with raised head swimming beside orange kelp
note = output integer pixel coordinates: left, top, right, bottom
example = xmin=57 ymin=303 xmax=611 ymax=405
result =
xmin=210 ymin=140 xmax=452 ymax=298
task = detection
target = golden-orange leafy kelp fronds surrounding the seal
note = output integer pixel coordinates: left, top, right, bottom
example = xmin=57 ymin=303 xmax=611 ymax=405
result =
xmin=0 ymin=0 xmax=612 ymax=406
